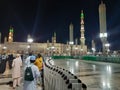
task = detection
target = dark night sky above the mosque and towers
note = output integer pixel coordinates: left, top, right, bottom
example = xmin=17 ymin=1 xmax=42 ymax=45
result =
xmin=0 ymin=0 xmax=120 ymax=50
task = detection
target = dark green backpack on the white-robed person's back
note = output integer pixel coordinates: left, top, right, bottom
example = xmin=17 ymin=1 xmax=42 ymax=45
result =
xmin=24 ymin=67 xmax=34 ymax=81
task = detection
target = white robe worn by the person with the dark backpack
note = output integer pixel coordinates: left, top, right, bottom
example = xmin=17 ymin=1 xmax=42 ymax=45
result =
xmin=23 ymin=64 xmax=40 ymax=90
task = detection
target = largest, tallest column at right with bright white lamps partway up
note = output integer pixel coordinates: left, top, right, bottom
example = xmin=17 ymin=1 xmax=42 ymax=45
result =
xmin=99 ymin=1 xmax=108 ymax=52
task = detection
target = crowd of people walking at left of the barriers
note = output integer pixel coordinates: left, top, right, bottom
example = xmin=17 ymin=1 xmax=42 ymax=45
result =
xmin=0 ymin=53 xmax=44 ymax=90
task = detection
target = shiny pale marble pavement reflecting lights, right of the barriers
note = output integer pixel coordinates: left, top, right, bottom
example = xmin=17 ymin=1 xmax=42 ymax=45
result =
xmin=54 ymin=59 xmax=120 ymax=90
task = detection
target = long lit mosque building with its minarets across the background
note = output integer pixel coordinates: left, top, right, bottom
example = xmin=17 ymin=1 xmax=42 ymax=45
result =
xmin=0 ymin=10 xmax=87 ymax=56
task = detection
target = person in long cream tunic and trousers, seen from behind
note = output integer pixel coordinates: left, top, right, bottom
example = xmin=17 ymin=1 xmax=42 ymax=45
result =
xmin=12 ymin=54 xmax=22 ymax=89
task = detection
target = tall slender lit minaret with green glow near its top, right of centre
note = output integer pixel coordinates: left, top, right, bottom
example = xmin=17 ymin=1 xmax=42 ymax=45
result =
xmin=80 ymin=10 xmax=85 ymax=49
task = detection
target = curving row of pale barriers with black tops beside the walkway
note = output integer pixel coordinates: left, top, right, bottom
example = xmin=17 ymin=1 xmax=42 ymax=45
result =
xmin=44 ymin=59 xmax=87 ymax=90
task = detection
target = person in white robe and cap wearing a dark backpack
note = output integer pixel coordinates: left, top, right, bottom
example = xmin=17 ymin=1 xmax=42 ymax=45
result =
xmin=23 ymin=56 xmax=40 ymax=90
